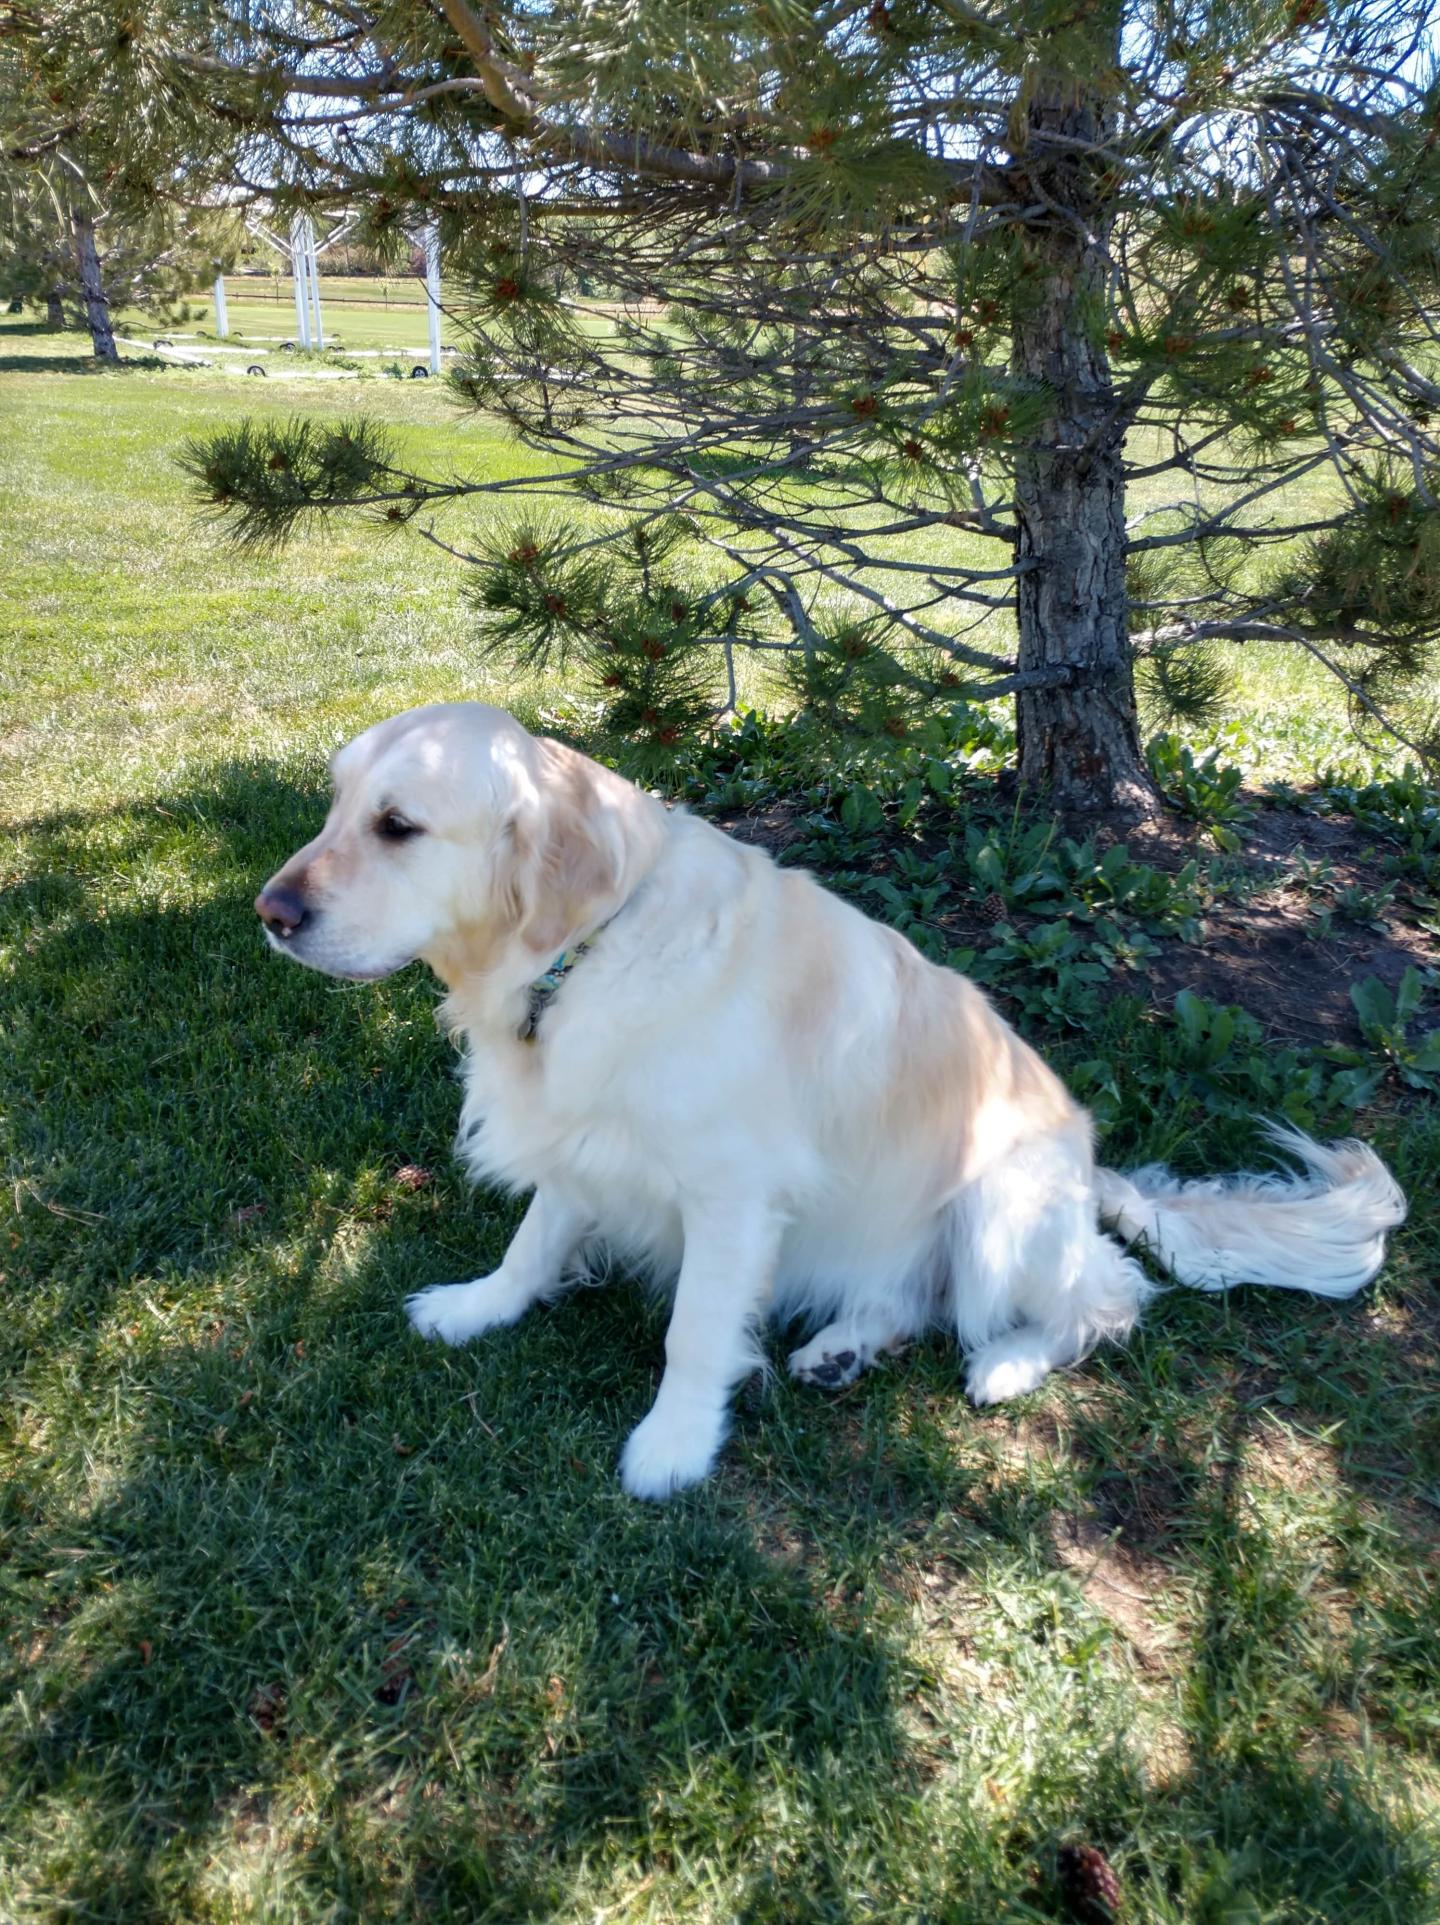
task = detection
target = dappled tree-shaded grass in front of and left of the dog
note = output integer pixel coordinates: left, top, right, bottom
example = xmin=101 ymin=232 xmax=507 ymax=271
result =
xmin=0 ymin=766 xmax=1434 ymax=1921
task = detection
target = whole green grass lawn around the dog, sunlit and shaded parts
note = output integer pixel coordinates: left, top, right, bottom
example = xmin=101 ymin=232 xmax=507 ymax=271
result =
xmin=0 ymin=327 xmax=1440 ymax=1925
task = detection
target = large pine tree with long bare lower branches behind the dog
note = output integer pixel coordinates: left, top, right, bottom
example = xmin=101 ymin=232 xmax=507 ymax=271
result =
xmin=25 ymin=0 xmax=1440 ymax=809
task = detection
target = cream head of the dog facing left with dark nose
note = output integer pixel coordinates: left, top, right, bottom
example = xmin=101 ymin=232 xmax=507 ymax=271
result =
xmin=254 ymin=703 xmax=658 ymax=982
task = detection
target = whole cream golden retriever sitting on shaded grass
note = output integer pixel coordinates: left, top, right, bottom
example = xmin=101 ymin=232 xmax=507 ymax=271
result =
xmin=256 ymin=703 xmax=1405 ymax=1498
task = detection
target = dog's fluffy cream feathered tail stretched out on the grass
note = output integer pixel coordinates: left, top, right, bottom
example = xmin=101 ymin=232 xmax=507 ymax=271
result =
xmin=1095 ymin=1122 xmax=1405 ymax=1297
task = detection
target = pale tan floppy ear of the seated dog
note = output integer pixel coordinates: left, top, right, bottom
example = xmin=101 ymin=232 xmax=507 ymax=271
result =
xmin=508 ymin=739 xmax=622 ymax=957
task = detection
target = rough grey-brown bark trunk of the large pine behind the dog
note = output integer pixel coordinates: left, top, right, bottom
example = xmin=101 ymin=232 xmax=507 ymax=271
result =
xmin=1011 ymin=81 xmax=1159 ymax=814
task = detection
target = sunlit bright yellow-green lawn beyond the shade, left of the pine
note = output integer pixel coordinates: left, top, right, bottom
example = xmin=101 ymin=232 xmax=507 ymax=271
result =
xmin=0 ymin=319 xmax=554 ymax=801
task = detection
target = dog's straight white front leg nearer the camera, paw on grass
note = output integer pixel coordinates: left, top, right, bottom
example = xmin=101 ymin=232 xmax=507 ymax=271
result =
xmin=620 ymin=1201 xmax=780 ymax=1498
